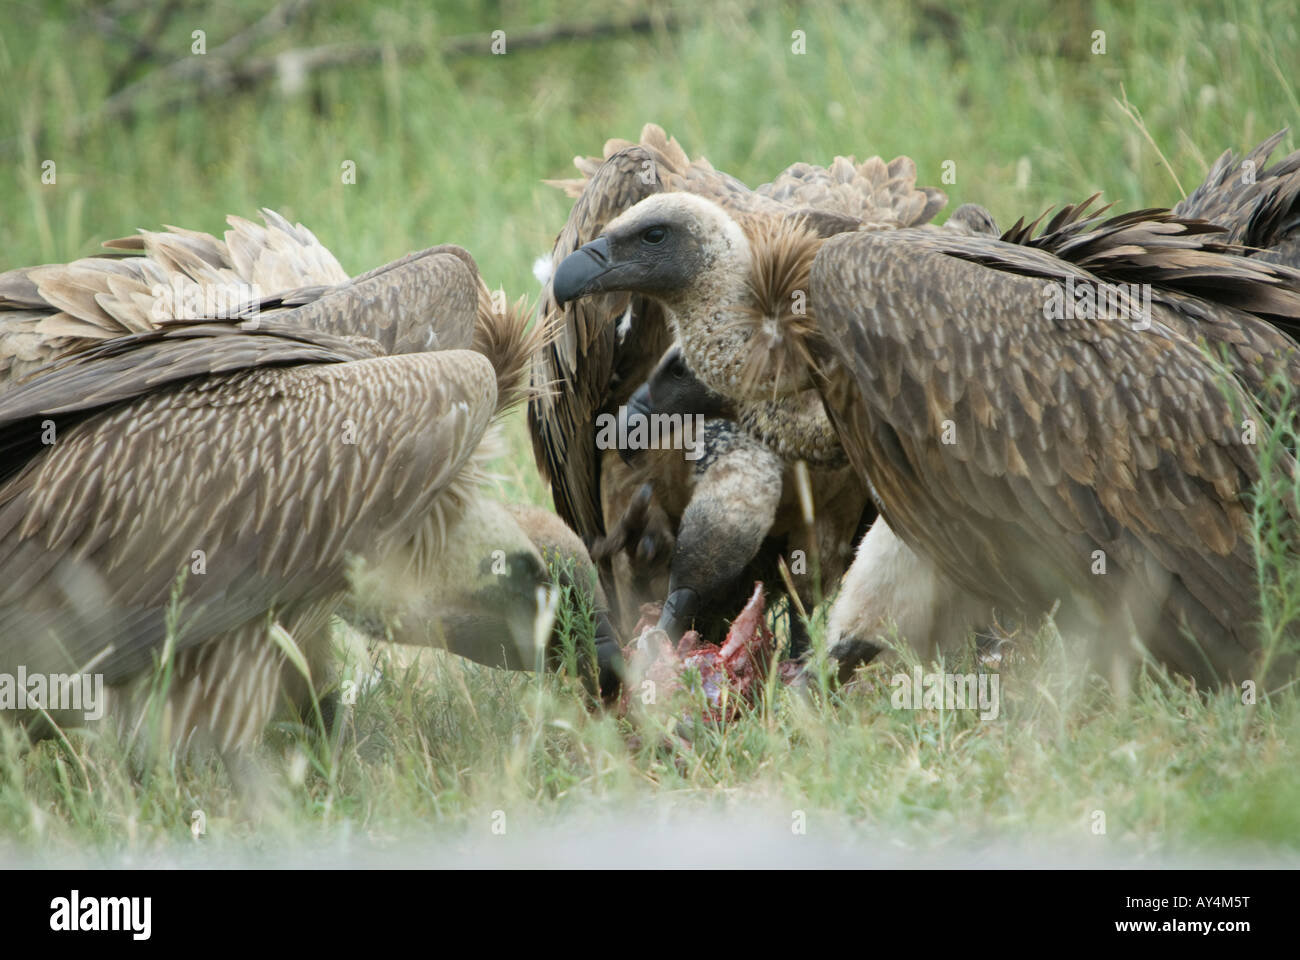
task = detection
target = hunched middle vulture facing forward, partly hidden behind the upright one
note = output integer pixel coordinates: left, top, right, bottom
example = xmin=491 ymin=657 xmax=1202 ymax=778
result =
xmin=529 ymin=124 xmax=951 ymax=642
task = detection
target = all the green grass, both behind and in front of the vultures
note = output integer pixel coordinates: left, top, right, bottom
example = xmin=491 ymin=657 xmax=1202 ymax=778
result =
xmin=0 ymin=0 xmax=1300 ymax=859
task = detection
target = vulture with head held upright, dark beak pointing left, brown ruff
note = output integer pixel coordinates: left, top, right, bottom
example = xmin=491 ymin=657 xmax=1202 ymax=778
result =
xmin=551 ymin=134 xmax=1300 ymax=684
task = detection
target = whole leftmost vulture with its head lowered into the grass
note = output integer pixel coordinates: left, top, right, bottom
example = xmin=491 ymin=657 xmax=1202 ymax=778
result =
xmin=0 ymin=211 xmax=618 ymax=753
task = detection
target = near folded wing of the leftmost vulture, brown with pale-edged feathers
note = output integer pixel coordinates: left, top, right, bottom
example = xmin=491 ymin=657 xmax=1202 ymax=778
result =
xmin=0 ymin=351 xmax=495 ymax=683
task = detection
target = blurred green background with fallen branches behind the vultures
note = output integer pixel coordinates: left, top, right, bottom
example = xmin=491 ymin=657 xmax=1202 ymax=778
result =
xmin=0 ymin=0 xmax=1300 ymax=294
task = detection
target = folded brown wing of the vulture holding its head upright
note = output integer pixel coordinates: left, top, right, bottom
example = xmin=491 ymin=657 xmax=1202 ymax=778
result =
xmin=813 ymin=230 xmax=1294 ymax=679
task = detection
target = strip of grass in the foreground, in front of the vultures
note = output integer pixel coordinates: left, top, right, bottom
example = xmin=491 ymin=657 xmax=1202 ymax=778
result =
xmin=0 ymin=621 xmax=1300 ymax=860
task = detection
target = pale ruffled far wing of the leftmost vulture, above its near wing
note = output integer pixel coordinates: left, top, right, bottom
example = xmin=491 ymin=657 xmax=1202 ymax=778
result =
xmin=0 ymin=209 xmax=478 ymax=393
